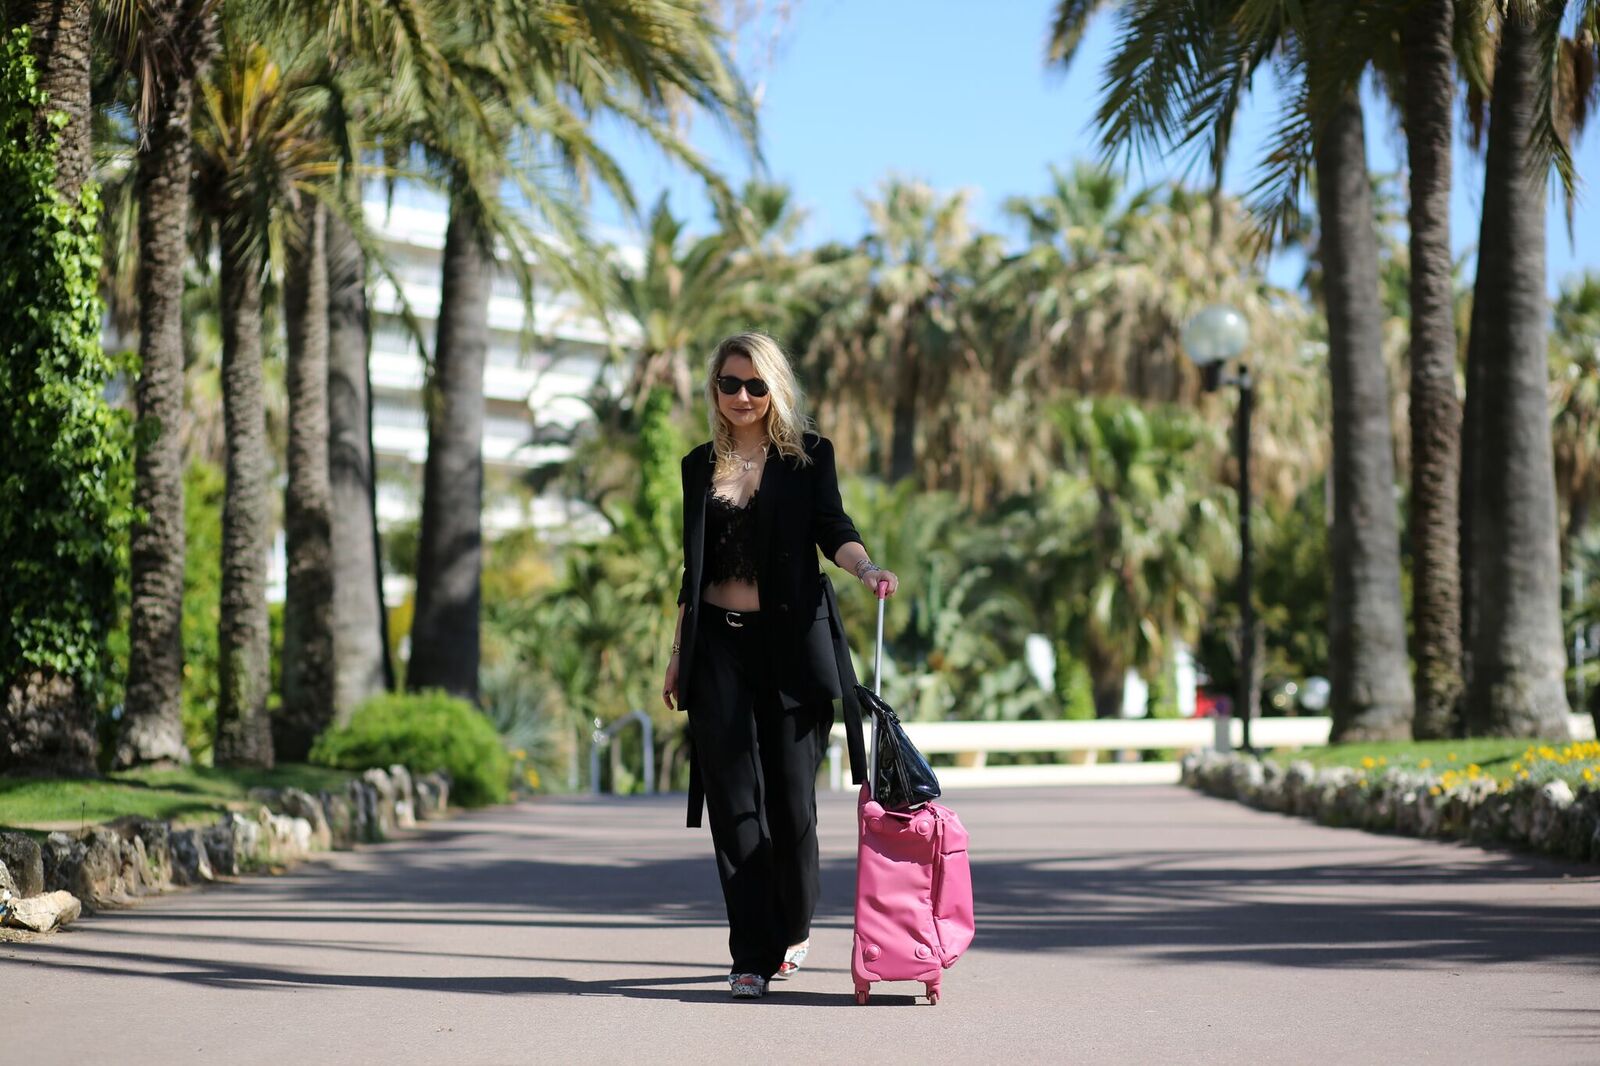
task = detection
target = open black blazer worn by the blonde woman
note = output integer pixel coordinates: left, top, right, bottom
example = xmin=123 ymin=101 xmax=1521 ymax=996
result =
xmin=678 ymin=434 xmax=861 ymax=709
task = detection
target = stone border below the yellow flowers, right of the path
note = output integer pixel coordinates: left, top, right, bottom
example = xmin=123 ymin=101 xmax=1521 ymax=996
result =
xmin=1181 ymin=751 xmax=1600 ymax=863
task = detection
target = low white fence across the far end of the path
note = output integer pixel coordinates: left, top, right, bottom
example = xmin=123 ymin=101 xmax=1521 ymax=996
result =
xmin=829 ymin=714 xmax=1595 ymax=789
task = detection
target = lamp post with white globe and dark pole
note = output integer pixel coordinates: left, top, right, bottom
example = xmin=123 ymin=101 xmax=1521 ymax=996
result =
xmin=1182 ymin=306 xmax=1256 ymax=752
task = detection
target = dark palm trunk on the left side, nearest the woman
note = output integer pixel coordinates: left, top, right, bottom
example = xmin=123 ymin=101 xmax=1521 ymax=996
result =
xmin=406 ymin=189 xmax=494 ymax=699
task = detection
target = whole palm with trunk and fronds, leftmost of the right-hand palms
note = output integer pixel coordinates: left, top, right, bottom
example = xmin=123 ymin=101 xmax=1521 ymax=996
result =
xmin=1051 ymin=0 xmax=1413 ymax=739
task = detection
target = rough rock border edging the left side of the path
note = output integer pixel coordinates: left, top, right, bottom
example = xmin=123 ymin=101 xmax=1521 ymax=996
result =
xmin=0 ymin=765 xmax=451 ymax=933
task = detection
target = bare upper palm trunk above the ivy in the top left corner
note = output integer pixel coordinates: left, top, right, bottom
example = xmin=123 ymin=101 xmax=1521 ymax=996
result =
xmin=6 ymin=0 xmax=94 ymax=203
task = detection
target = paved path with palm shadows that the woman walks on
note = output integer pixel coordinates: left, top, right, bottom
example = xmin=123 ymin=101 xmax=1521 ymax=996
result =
xmin=0 ymin=787 xmax=1600 ymax=1066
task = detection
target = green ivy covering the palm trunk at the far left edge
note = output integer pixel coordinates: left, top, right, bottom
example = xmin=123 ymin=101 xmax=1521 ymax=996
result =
xmin=0 ymin=29 xmax=133 ymax=687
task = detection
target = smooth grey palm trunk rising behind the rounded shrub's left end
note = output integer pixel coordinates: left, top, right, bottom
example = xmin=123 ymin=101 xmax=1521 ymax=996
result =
xmin=328 ymin=204 xmax=394 ymax=722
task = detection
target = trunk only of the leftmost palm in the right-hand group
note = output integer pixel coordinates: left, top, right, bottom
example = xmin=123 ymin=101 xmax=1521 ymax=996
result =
xmin=1315 ymin=80 xmax=1413 ymax=741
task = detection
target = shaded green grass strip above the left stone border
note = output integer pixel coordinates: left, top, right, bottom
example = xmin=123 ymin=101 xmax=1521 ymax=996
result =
xmin=0 ymin=765 xmax=355 ymax=831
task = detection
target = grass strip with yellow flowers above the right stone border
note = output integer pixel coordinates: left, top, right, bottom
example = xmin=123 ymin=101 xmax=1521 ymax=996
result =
xmin=1267 ymin=736 xmax=1600 ymax=787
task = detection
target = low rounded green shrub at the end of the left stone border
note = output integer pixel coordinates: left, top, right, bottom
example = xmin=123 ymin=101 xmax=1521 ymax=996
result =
xmin=310 ymin=690 xmax=510 ymax=807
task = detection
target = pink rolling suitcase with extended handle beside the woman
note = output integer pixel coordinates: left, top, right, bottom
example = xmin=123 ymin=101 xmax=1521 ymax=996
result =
xmin=850 ymin=583 xmax=973 ymax=1004
